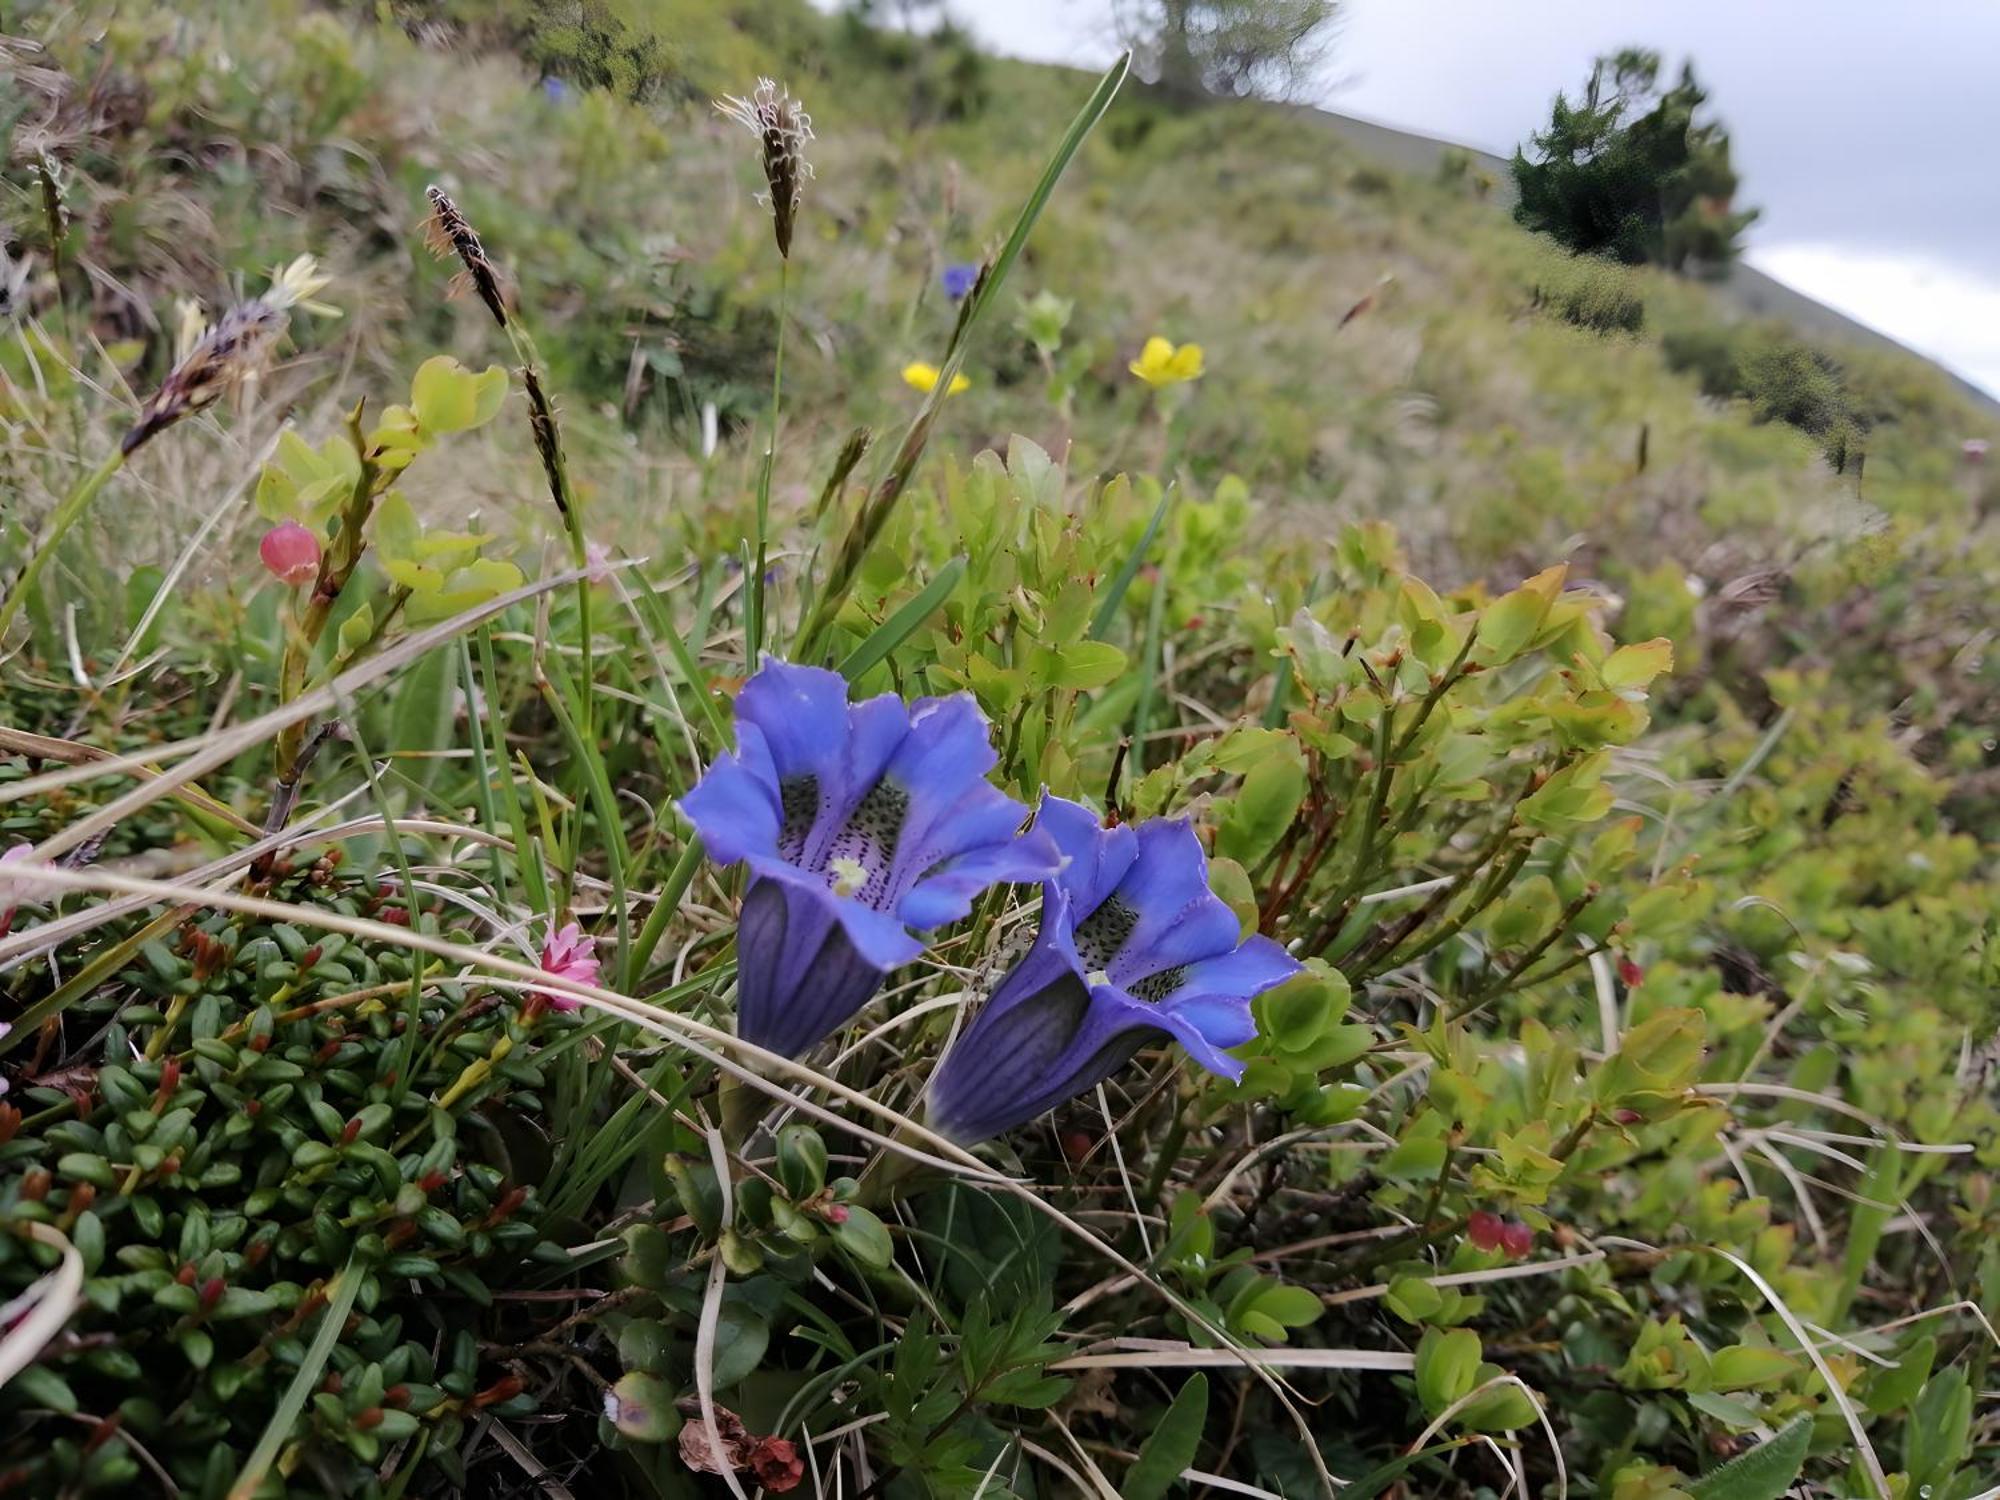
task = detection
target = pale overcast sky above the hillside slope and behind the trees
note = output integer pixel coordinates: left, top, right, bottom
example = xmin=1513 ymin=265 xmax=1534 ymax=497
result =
xmin=950 ymin=0 xmax=2000 ymax=394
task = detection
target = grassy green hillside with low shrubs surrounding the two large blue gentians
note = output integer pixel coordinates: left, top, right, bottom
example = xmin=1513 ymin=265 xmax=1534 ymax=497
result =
xmin=0 ymin=0 xmax=2000 ymax=1500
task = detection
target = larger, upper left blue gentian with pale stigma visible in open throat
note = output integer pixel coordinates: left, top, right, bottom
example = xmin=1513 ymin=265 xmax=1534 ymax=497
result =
xmin=682 ymin=658 xmax=1058 ymax=1058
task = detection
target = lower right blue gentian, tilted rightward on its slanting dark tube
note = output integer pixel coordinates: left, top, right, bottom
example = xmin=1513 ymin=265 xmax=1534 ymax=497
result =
xmin=930 ymin=796 xmax=1300 ymax=1146
